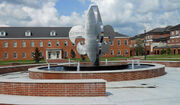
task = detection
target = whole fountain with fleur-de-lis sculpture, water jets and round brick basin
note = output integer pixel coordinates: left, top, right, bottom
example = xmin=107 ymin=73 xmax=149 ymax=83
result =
xmin=29 ymin=5 xmax=164 ymax=81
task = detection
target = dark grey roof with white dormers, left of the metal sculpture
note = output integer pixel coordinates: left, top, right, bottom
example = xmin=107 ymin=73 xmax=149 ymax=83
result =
xmin=0 ymin=27 xmax=71 ymax=38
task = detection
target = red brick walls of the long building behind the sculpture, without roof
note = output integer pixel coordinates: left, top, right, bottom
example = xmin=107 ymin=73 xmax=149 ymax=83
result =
xmin=0 ymin=37 xmax=130 ymax=60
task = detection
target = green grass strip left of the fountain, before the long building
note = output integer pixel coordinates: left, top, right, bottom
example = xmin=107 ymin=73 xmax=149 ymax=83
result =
xmin=0 ymin=60 xmax=45 ymax=65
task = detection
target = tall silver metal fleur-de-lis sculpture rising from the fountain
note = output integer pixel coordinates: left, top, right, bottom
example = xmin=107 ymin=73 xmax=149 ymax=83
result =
xmin=69 ymin=5 xmax=115 ymax=66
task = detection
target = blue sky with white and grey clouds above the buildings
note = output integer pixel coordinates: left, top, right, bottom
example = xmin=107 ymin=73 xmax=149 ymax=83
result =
xmin=0 ymin=0 xmax=180 ymax=36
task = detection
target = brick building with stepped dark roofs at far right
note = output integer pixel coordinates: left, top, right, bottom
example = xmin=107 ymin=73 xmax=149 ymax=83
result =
xmin=130 ymin=24 xmax=180 ymax=56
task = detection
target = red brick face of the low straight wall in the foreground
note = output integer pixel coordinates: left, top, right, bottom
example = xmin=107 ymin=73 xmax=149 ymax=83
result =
xmin=0 ymin=82 xmax=106 ymax=97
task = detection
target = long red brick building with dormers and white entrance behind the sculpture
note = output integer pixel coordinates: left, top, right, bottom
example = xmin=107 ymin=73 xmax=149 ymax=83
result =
xmin=0 ymin=27 xmax=130 ymax=60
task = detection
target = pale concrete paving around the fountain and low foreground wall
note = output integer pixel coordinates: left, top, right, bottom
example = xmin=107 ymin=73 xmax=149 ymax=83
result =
xmin=0 ymin=67 xmax=180 ymax=105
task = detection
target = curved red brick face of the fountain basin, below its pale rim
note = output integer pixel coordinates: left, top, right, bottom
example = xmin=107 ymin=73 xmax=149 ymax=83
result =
xmin=29 ymin=67 xmax=165 ymax=82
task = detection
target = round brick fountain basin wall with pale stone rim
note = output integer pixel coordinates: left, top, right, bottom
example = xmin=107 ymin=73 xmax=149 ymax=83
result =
xmin=29 ymin=63 xmax=165 ymax=82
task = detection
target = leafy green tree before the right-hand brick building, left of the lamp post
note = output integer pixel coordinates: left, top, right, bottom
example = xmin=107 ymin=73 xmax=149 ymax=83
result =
xmin=135 ymin=38 xmax=144 ymax=56
